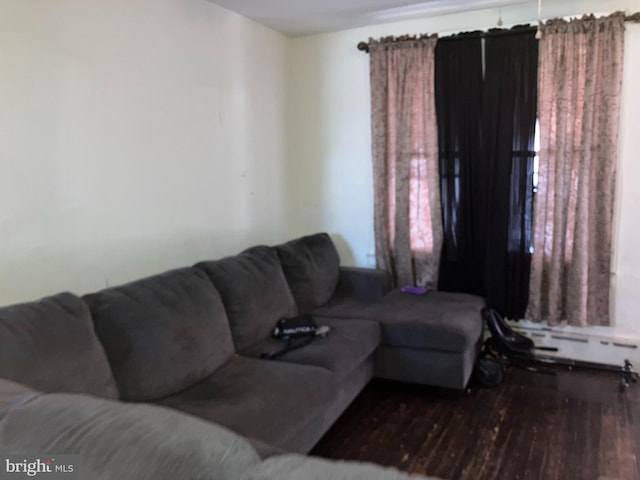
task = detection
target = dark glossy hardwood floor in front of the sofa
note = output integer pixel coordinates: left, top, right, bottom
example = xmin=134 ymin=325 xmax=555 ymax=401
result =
xmin=311 ymin=368 xmax=640 ymax=480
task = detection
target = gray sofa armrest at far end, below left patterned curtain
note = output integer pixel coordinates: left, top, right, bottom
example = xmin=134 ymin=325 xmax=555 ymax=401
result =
xmin=336 ymin=267 xmax=391 ymax=301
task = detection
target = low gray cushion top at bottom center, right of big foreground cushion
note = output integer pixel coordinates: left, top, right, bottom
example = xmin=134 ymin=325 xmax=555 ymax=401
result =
xmin=241 ymin=454 xmax=436 ymax=480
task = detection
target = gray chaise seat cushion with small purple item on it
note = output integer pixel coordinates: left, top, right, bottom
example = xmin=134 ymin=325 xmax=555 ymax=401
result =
xmin=361 ymin=290 xmax=484 ymax=353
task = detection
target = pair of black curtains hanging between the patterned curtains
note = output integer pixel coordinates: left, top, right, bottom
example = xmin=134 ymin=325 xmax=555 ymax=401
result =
xmin=435 ymin=27 xmax=538 ymax=319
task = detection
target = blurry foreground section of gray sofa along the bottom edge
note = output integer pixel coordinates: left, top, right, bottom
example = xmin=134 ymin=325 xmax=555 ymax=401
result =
xmin=0 ymin=379 xmax=436 ymax=480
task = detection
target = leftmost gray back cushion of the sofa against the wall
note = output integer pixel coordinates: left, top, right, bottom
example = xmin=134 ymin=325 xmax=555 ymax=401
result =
xmin=0 ymin=293 xmax=118 ymax=398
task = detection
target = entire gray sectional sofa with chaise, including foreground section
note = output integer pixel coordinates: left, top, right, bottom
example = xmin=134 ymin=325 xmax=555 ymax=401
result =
xmin=0 ymin=234 xmax=484 ymax=479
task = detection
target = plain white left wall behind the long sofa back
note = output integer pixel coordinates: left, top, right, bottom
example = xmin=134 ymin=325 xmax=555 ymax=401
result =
xmin=0 ymin=0 xmax=287 ymax=305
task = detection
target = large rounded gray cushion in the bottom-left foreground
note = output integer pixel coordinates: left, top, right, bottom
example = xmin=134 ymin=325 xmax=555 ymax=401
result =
xmin=0 ymin=394 xmax=260 ymax=480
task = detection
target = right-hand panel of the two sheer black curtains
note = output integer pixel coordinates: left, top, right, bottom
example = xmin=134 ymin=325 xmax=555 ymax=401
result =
xmin=483 ymin=28 xmax=538 ymax=319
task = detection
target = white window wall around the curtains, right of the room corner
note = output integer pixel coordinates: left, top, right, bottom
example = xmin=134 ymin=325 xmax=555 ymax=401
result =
xmin=287 ymin=0 xmax=640 ymax=337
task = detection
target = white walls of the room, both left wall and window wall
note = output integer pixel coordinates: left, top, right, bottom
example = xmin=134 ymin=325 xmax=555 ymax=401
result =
xmin=0 ymin=0 xmax=640 ymax=337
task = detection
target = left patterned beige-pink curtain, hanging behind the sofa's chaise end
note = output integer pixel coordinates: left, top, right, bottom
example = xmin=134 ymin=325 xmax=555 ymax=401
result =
xmin=369 ymin=37 xmax=442 ymax=287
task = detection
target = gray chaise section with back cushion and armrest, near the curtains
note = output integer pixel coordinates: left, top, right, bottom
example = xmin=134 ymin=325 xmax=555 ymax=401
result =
xmin=276 ymin=234 xmax=485 ymax=390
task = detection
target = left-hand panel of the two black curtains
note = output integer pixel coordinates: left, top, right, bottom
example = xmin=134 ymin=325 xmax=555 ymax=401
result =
xmin=435 ymin=33 xmax=484 ymax=295
